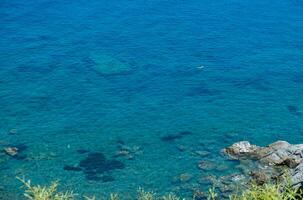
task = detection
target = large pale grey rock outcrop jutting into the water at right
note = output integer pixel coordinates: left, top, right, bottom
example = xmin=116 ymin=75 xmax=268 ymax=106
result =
xmin=222 ymin=141 xmax=303 ymax=188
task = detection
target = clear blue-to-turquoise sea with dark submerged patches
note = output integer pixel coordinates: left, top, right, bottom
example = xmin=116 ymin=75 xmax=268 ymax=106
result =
xmin=0 ymin=0 xmax=303 ymax=197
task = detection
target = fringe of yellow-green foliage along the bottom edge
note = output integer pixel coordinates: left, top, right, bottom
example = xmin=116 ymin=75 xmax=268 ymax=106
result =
xmin=18 ymin=178 xmax=303 ymax=200
